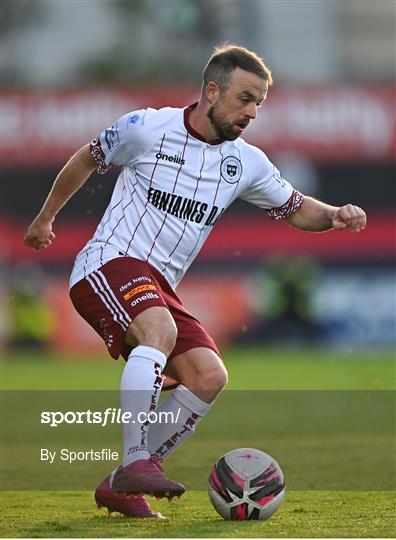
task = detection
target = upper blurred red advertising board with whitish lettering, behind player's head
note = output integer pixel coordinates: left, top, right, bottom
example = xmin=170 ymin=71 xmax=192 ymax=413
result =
xmin=1 ymin=85 xmax=396 ymax=168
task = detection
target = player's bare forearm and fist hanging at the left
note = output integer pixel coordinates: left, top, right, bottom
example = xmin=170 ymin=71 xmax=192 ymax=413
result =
xmin=24 ymin=144 xmax=97 ymax=249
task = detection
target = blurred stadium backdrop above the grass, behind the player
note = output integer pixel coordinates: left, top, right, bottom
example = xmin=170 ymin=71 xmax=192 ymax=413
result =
xmin=1 ymin=0 xmax=395 ymax=353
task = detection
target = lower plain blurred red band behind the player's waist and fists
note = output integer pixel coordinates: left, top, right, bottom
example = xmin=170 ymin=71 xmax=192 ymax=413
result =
xmin=0 ymin=213 xmax=396 ymax=265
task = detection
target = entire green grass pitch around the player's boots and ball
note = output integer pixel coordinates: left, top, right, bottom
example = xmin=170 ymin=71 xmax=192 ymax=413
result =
xmin=1 ymin=348 xmax=396 ymax=538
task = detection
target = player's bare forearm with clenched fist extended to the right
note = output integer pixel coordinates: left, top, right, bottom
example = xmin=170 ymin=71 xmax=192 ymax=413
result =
xmin=286 ymin=197 xmax=367 ymax=232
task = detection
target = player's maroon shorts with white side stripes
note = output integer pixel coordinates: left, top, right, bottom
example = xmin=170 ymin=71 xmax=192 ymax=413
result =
xmin=70 ymin=257 xmax=220 ymax=360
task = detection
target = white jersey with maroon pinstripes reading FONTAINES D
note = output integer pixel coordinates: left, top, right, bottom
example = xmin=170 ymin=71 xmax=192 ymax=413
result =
xmin=70 ymin=105 xmax=303 ymax=288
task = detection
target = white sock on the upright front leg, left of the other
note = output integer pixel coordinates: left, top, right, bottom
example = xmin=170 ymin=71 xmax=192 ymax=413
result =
xmin=121 ymin=345 xmax=166 ymax=467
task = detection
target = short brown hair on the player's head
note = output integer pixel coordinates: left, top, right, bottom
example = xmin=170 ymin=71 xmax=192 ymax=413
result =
xmin=203 ymin=44 xmax=272 ymax=91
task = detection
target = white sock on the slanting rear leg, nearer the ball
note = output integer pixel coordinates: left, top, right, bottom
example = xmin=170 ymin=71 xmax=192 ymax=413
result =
xmin=148 ymin=384 xmax=210 ymax=459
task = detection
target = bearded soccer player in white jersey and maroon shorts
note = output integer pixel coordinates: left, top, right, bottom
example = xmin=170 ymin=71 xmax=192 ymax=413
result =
xmin=25 ymin=45 xmax=366 ymax=517
